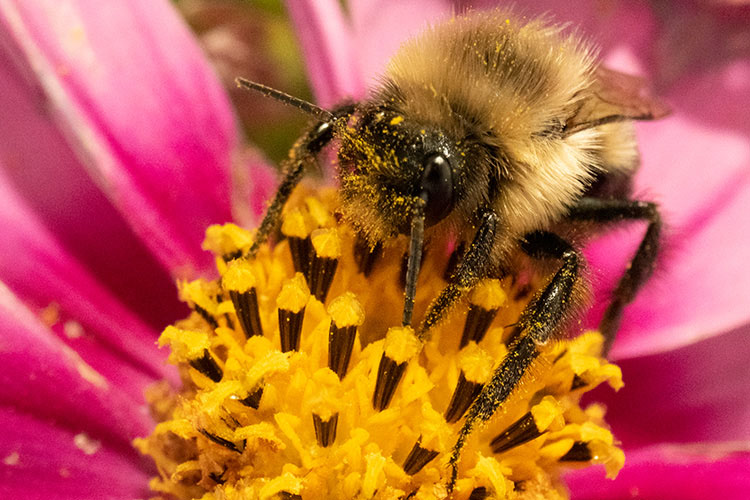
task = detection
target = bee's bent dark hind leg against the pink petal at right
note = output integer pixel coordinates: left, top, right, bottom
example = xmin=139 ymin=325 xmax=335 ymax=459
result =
xmin=569 ymin=198 xmax=662 ymax=353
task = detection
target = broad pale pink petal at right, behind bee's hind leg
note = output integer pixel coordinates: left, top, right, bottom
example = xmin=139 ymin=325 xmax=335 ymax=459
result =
xmin=588 ymin=62 xmax=750 ymax=357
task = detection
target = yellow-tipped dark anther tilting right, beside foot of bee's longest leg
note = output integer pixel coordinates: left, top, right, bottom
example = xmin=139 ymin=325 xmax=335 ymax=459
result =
xmin=490 ymin=396 xmax=564 ymax=453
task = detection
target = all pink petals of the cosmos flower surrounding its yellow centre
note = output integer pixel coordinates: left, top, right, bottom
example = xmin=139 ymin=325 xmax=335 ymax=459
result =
xmin=0 ymin=0 xmax=750 ymax=499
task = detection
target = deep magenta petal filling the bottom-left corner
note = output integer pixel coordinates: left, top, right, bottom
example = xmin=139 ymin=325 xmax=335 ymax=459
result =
xmin=0 ymin=407 xmax=152 ymax=500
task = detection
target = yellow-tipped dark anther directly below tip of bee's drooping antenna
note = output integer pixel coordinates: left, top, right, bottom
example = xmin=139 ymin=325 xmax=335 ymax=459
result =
xmin=372 ymin=326 xmax=422 ymax=411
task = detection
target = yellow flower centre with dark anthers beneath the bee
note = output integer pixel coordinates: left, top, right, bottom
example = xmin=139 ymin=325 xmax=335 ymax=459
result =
xmin=135 ymin=189 xmax=624 ymax=500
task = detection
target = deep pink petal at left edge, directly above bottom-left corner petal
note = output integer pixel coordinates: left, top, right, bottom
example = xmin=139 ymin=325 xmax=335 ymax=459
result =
xmin=0 ymin=286 xmax=152 ymax=450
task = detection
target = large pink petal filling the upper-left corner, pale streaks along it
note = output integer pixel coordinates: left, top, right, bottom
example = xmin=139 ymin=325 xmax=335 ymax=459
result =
xmin=0 ymin=0 xmax=237 ymax=276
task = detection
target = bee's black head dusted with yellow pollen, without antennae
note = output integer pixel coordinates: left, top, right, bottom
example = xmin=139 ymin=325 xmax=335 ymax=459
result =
xmin=338 ymin=107 xmax=465 ymax=241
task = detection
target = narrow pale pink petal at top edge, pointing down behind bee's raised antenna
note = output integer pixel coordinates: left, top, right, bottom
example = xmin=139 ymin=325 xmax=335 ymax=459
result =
xmin=286 ymin=0 xmax=365 ymax=107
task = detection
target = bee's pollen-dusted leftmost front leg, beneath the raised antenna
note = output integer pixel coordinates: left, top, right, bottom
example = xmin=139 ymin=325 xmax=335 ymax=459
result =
xmin=245 ymin=104 xmax=354 ymax=258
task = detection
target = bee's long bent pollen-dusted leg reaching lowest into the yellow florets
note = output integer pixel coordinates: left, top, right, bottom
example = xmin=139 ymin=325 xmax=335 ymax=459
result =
xmin=448 ymin=231 xmax=581 ymax=489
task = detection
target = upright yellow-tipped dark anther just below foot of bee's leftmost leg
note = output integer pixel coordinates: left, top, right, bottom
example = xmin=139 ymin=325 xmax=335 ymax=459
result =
xmin=221 ymin=259 xmax=263 ymax=338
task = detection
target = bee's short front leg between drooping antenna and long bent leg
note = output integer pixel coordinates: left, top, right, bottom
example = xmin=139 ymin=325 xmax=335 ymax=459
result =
xmin=418 ymin=210 xmax=497 ymax=338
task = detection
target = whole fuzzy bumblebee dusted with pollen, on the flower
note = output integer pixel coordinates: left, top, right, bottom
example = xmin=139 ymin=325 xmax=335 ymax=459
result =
xmin=238 ymin=10 xmax=668 ymax=490
